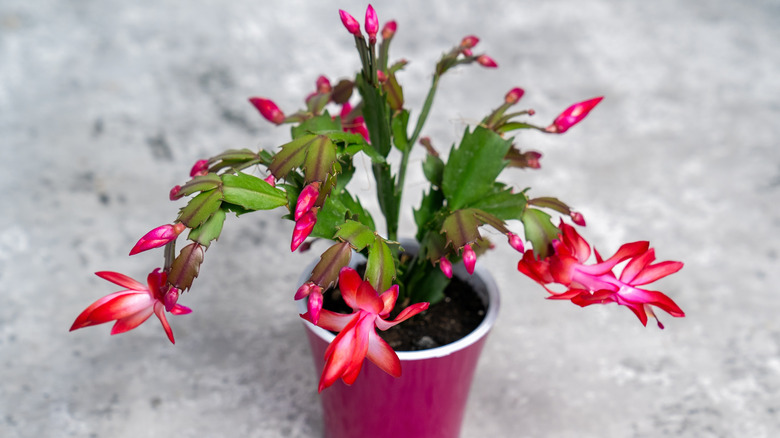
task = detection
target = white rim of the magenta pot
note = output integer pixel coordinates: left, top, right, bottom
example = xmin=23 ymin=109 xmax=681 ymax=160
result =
xmin=298 ymin=254 xmax=501 ymax=361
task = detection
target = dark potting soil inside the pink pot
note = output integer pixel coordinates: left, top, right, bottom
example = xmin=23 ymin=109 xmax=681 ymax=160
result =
xmin=323 ymin=270 xmax=486 ymax=351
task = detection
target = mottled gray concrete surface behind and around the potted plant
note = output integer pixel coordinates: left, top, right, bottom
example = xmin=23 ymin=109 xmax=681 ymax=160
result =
xmin=0 ymin=0 xmax=780 ymax=438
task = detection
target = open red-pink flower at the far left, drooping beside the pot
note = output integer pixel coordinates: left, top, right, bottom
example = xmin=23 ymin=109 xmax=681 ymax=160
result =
xmin=70 ymin=268 xmax=192 ymax=344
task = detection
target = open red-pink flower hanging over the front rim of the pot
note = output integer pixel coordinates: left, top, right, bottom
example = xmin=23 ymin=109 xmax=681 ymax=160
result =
xmin=301 ymin=267 xmax=428 ymax=391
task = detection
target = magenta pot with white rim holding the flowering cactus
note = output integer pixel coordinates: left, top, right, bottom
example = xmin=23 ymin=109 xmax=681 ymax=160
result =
xmin=301 ymin=257 xmax=499 ymax=438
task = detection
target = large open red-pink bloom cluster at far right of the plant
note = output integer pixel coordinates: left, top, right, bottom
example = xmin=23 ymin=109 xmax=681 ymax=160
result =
xmin=517 ymin=223 xmax=685 ymax=328
